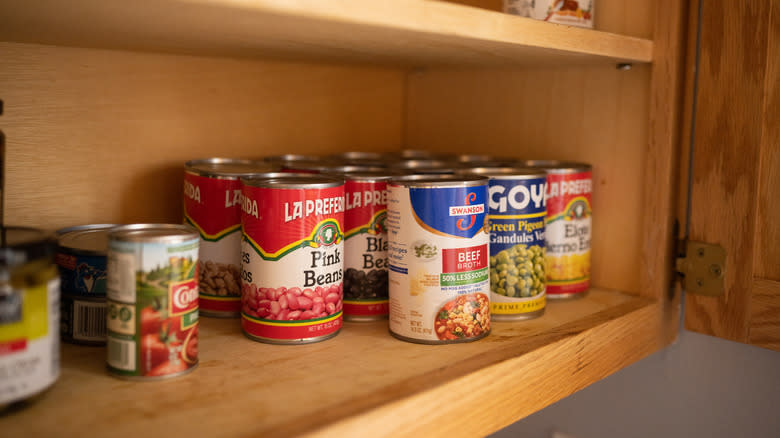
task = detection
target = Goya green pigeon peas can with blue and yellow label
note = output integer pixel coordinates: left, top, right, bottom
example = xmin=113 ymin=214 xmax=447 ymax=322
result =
xmin=454 ymin=167 xmax=547 ymax=321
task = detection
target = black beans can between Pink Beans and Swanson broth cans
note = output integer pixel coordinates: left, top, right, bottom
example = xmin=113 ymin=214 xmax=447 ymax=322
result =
xmin=344 ymin=172 xmax=393 ymax=321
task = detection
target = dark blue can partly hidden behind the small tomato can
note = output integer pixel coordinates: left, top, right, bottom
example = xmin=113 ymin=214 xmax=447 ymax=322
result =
xmin=55 ymin=224 xmax=116 ymax=345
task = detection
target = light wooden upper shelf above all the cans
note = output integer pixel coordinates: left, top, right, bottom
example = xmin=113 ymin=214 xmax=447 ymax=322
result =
xmin=0 ymin=0 xmax=653 ymax=66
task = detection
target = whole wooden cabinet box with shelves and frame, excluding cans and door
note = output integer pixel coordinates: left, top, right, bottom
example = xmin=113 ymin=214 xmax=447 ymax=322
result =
xmin=0 ymin=0 xmax=777 ymax=436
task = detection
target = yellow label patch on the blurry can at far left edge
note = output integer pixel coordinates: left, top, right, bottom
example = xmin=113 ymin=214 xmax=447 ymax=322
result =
xmin=0 ymin=283 xmax=49 ymax=342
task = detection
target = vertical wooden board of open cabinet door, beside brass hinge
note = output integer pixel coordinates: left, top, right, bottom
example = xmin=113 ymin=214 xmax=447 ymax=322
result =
xmin=685 ymin=0 xmax=776 ymax=342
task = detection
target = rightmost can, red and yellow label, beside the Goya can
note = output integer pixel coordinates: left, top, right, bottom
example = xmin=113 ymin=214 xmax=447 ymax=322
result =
xmin=527 ymin=161 xmax=593 ymax=299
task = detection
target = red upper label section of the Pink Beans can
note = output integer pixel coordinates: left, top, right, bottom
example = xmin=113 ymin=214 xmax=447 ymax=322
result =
xmin=241 ymin=186 xmax=344 ymax=259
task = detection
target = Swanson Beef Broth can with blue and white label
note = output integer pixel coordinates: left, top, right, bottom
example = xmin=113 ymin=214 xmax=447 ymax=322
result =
xmin=387 ymin=175 xmax=490 ymax=344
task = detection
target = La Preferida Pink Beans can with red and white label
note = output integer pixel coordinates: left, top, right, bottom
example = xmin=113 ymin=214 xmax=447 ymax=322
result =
xmin=241 ymin=174 xmax=344 ymax=344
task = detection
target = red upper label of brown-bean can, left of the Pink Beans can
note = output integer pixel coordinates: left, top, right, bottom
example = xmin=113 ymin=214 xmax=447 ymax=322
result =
xmin=184 ymin=172 xmax=241 ymax=241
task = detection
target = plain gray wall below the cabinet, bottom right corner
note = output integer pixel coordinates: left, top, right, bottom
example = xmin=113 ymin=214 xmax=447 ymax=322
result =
xmin=492 ymin=331 xmax=780 ymax=438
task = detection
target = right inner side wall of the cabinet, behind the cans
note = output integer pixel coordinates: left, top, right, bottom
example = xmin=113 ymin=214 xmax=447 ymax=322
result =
xmin=406 ymin=66 xmax=650 ymax=293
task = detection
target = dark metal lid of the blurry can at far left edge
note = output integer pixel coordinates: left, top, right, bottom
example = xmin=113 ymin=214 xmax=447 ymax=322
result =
xmin=0 ymin=226 xmax=56 ymax=267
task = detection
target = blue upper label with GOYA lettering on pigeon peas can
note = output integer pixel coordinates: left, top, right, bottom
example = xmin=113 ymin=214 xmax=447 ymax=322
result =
xmin=488 ymin=177 xmax=547 ymax=255
